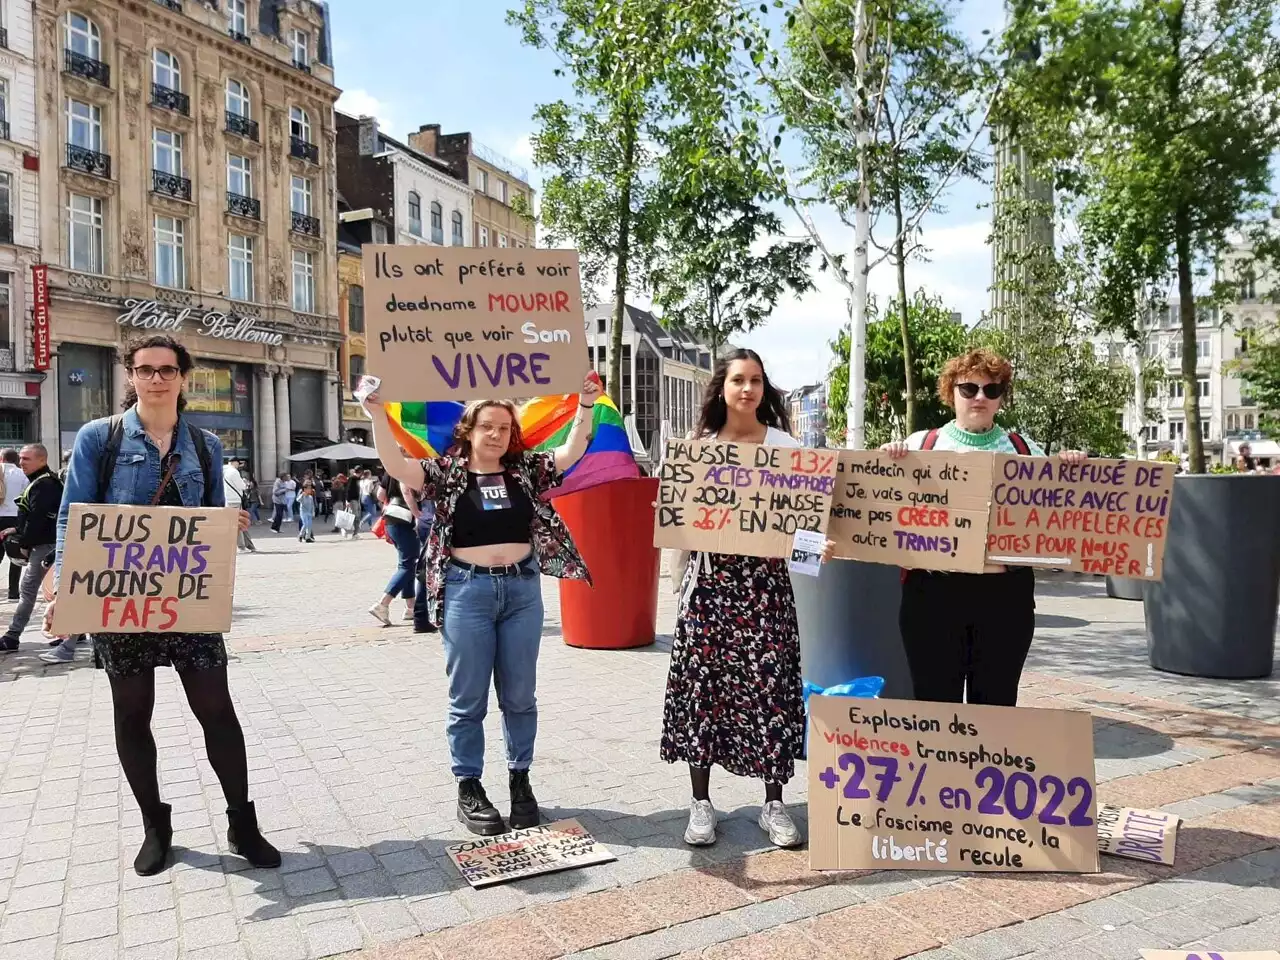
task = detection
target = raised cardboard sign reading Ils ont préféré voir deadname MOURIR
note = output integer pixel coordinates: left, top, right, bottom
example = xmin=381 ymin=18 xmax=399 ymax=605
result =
xmin=364 ymin=244 xmax=588 ymax=401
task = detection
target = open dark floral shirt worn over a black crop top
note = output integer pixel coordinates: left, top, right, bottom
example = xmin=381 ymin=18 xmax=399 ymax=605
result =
xmin=421 ymin=451 xmax=591 ymax=623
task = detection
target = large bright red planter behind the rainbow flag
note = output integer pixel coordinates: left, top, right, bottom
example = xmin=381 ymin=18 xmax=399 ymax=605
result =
xmin=556 ymin=477 xmax=662 ymax=650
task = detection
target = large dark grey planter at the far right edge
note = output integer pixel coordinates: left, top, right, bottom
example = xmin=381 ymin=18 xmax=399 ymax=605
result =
xmin=1144 ymin=475 xmax=1280 ymax=680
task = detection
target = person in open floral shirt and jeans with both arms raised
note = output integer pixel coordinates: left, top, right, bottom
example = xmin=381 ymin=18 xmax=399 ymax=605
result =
xmin=364 ymin=374 xmax=600 ymax=836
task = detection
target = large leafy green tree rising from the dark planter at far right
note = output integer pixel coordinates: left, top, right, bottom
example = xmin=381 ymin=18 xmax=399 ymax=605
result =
xmin=1002 ymin=0 xmax=1280 ymax=472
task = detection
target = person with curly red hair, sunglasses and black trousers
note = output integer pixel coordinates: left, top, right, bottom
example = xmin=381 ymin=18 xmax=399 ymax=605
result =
xmin=881 ymin=349 xmax=1084 ymax=707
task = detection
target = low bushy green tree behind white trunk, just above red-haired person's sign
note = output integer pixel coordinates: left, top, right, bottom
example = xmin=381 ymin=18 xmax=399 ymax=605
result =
xmin=827 ymin=289 xmax=968 ymax=447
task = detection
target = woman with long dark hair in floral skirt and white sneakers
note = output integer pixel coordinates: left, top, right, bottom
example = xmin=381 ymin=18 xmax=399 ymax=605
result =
xmin=660 ymin=349 xmax=832 ymax=846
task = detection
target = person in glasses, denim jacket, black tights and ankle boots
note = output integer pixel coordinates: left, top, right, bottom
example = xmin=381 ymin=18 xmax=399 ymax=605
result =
xmin=45 ymin=335 xmax=280 ymax=877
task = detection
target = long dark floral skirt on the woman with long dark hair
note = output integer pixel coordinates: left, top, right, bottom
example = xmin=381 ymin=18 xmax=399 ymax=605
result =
xmin=662 ymin=553 xmax=804 ymax=783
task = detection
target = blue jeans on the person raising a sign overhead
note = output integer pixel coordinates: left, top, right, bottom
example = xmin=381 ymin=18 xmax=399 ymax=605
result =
xmin=440 ymin=558 xmax=543 ymax=780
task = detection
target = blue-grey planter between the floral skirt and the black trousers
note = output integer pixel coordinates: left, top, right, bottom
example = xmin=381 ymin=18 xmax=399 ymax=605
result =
xmin=791 ymin=561 xmax=913 ymax=700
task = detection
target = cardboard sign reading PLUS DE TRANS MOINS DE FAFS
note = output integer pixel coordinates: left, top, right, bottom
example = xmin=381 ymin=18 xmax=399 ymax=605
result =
xmin=52 ymin=503 xmax=239 ymax=636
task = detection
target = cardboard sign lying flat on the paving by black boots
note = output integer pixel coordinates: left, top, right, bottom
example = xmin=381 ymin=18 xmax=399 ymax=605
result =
xmin=444 ymin=820 xmax=617 ymax=888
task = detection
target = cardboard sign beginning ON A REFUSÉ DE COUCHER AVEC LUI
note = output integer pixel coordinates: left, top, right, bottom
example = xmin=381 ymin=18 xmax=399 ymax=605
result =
xmin=987 ymin=453 xmax=1174 ymax=580
